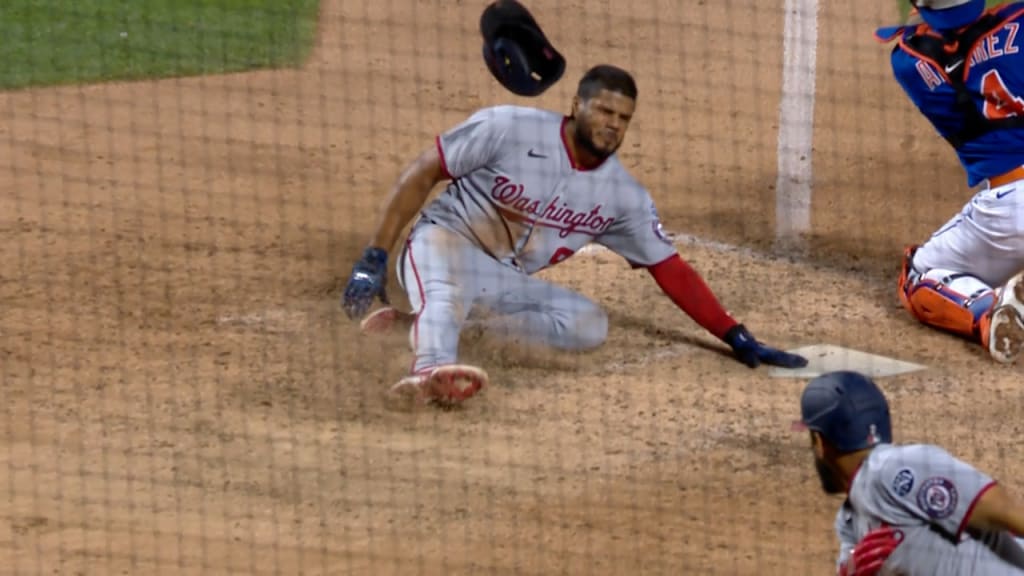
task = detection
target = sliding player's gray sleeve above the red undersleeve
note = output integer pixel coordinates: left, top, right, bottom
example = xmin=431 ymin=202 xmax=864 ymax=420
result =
xmin=595 ymin=190 xmax=677 ymax=268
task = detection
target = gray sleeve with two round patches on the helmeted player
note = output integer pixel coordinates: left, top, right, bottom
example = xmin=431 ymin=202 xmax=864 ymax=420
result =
xmin=879 ymin=445 xmax=995 ymax=538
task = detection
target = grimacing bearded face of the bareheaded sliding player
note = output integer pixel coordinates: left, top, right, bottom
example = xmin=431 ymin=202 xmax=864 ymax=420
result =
xmin=574 ymin=90 xmax=636 ymax=159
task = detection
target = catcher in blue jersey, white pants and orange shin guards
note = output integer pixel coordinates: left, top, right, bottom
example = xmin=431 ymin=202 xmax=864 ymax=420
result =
xmin=876 ymin=0 xmax=1024 ymax=363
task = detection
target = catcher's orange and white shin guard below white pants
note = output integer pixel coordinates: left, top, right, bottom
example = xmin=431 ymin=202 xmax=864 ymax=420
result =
xmin=899 ymin=248 xmax=996 ymax=340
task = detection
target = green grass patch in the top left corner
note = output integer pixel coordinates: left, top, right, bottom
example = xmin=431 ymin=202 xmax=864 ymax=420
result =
xmin=0 ymin=0 xmax=319 ymax=89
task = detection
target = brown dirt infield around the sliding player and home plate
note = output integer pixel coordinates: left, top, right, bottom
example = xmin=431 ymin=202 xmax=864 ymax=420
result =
xmin=0 ymin=0 xmax=1022 ymax=575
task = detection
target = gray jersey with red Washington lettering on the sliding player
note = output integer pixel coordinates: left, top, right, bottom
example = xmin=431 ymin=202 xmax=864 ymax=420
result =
xmin=422 ymin=106 xmax=676 ymax=274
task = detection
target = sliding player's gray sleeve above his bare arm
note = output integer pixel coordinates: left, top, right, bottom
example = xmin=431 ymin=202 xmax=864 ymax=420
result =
xmin=437 ymin=107 xmax=509 ymax=178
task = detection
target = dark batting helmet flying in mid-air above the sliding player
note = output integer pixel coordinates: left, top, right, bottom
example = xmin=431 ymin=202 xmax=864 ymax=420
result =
xmin=480 ymin=0 xmax=565 ymax=96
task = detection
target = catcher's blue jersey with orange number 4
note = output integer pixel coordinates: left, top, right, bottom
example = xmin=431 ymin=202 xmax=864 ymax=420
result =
xmin=890 ymin=2 xmax=1024 ymax=187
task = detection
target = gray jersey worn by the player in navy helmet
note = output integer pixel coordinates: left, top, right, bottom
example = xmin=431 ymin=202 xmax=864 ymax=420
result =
xmin=836 ymin=444 xmax=1024 ymax=576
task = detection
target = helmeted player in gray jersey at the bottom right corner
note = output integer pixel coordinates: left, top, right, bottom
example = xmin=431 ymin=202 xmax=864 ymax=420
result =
xmin=797 ymin=371 xmax=1024 ymax=576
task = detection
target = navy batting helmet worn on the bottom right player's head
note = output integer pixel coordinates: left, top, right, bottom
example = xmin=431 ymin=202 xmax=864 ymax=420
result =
xmin=798 ymin=370 xmax=893 ymax=453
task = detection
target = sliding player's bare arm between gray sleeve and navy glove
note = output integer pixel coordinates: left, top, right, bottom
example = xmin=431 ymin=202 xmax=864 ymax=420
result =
xmin=370 ymin=147 xmax=444 ymax=251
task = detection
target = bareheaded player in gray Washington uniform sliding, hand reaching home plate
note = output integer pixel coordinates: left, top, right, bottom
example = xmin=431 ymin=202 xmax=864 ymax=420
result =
xmin=342 ymin=66 xmax=807 ymax=404
